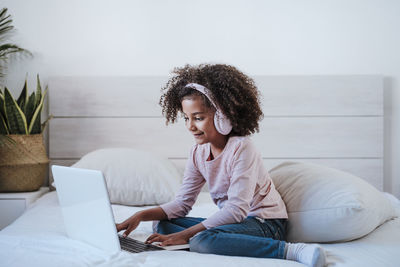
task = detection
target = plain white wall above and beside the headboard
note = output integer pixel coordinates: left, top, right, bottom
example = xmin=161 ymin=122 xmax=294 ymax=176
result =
xmin=1 ymin=0 xmax=400 ymax=197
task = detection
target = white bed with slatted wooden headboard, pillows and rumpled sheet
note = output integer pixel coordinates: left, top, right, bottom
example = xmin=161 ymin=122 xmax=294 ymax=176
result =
xmin=0 ymin=75 xmax=400 ymax=266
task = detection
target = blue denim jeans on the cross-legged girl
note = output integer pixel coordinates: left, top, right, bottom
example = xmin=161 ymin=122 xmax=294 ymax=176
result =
xmin=157 ymin=216 xmax=287 ymax=259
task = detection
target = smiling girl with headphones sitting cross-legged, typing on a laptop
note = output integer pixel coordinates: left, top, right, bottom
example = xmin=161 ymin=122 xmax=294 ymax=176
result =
xmin=117 ymin=64 xmax=325 ymax=266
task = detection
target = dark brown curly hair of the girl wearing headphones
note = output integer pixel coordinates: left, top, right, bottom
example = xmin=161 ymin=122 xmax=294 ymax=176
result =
xmin=159 ymin=64 xmax=263 ymax=136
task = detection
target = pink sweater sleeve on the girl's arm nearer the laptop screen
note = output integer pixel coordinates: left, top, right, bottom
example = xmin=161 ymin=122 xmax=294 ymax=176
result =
xmin=160 ymin=145 xmax=205 ymax=220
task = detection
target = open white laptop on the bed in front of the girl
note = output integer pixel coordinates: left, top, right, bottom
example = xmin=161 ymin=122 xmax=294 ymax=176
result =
xmin=52 ymin=165 xmax=189 ymax=253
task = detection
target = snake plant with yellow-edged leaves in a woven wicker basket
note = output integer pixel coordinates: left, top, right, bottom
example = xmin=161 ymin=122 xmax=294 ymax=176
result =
xmin=0 ymin=75 xmax=51 ymax=192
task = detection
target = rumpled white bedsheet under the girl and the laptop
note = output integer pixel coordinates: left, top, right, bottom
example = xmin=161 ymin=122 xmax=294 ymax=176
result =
xmin=0 ymin=192 xmax=400 ymax=267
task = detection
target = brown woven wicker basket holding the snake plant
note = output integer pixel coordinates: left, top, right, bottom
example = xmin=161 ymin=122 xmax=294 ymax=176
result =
xmin=0 ymin=134 xmax=49 ymax=192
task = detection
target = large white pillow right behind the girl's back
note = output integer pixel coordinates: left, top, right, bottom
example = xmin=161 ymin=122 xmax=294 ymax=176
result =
xmin=270 ymin=162 xmax=394 ymax=242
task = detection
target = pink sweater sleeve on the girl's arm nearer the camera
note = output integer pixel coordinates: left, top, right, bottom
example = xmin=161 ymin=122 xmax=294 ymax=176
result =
xmin=202 ymin=142 xmax=261 ymax=229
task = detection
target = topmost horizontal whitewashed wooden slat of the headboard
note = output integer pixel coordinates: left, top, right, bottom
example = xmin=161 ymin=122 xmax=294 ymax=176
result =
xmin=49 ymin=75 xmax=383 ymax=117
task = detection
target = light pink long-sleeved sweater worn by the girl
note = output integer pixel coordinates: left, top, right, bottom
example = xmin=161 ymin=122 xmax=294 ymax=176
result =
xmin=160 ymin=137 xmax=288 ymax=229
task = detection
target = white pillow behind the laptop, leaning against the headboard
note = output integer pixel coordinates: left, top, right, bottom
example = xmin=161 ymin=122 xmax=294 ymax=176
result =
xmin=72 ymin=148 xmax=181 ymax=206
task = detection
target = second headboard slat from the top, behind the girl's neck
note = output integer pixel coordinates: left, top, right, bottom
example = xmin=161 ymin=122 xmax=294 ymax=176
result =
xmin=50 ymin=117 xmax=382 ymax=158
